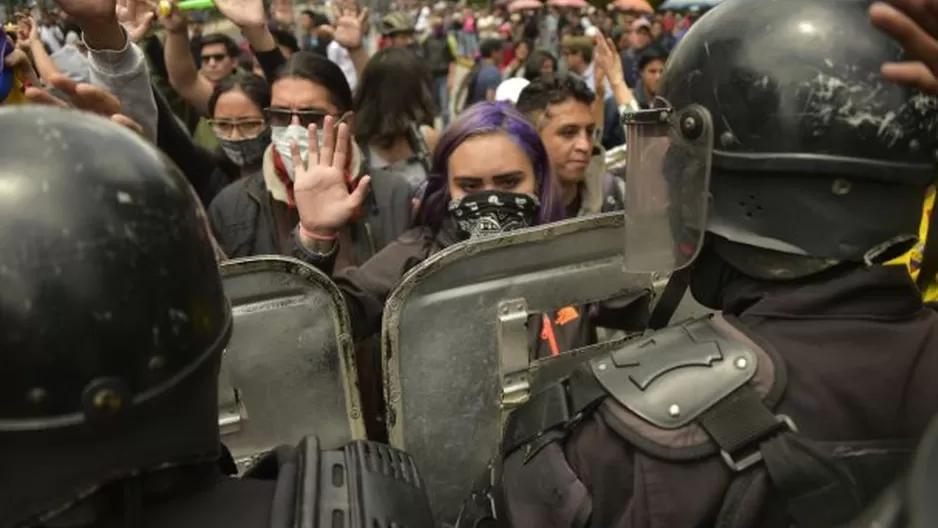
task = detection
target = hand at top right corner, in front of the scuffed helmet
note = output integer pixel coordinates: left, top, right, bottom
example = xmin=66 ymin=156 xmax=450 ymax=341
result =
xmin=869 ymin=0 xmax=938 ymax=95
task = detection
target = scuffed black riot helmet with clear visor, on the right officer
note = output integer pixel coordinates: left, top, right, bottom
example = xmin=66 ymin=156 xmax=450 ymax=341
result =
xmin=625 ymin=0 xmax=938 ymax=278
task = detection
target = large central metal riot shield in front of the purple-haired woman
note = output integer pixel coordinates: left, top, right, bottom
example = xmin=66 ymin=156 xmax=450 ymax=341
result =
xmin=383 ymin=213 xmax=652 ymax=522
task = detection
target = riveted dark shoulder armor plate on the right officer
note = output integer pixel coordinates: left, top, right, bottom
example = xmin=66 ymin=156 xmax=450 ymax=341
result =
xmin=590 ymin=316 xmax=758 ymax=429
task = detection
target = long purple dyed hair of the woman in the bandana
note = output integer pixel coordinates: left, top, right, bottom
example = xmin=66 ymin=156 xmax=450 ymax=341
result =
xmin=416 ymin=101 xmax=566 ymax=231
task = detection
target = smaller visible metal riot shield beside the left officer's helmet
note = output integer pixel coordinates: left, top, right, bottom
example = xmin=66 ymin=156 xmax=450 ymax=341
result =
xmin=218 ymin=256 xmax=365 ymax=468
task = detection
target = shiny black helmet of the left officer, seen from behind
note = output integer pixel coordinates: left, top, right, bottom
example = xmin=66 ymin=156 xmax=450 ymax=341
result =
xmin=0 ymin=107 xmax=231 ymax=526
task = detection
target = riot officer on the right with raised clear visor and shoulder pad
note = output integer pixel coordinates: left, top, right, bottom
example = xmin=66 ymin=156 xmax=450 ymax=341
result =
xmin=459 ymin=0 xmax=938 ymax=528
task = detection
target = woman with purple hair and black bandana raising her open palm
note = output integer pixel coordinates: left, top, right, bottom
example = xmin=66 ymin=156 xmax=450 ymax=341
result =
xmin=286 ymin=102 xmax=572 ymax=346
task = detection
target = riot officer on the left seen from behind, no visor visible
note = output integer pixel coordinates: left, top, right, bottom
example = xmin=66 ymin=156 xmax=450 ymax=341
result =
xmin=0 ymin=107 xmax=431 ymax=528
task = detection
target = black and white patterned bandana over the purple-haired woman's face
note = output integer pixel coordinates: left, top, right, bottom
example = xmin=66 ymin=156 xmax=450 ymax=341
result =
xmin=449 ymin=191 xmax=541 ymax=240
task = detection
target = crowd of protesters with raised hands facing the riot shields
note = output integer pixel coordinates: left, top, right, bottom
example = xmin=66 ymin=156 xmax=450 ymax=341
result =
xmin=5 ymin=0 xmax=704 ymax=438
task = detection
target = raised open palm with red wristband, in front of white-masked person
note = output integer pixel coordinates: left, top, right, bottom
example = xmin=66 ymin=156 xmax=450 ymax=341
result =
xmin=293 ymin=117 xmax=371 ymax=237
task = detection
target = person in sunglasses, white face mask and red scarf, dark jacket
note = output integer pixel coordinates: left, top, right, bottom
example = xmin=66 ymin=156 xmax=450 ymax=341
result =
xmin=209 ymin=52 xmax=413 ymax=269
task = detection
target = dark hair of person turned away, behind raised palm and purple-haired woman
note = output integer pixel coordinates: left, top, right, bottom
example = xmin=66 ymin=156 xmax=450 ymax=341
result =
xmin=353 ymin=47 xmax=436 ymax=147
